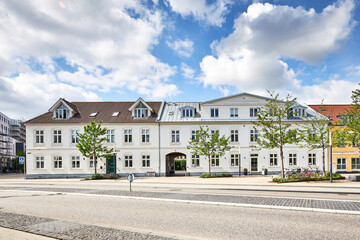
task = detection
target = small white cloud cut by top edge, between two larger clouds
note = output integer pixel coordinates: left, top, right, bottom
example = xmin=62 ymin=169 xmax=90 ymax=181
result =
xmin=167 ymin=0 xmax=232 ymax=26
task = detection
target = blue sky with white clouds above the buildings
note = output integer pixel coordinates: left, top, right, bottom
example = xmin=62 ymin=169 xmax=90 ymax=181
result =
xmin=0 ymin=0 xmax=360 ymax=119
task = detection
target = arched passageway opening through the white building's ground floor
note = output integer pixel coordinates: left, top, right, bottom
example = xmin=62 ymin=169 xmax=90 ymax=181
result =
xmin=166 ymin=152 xmax=186 ymax=176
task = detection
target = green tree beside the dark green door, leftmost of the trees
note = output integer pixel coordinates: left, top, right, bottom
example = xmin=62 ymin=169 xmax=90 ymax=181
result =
xmin=76 ymin=121 xmax=113 ymax=174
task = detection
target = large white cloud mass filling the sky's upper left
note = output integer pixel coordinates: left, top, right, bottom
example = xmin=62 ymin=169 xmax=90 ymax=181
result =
xmin=0 ymin=0 xmax=179 ymax=119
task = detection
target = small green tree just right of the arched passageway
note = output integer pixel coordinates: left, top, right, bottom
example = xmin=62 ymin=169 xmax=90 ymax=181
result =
xmin=187 ymin=126 xmax=231 ymax=175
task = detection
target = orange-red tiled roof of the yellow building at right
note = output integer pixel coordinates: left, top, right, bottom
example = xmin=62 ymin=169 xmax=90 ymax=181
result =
xmin=308 ymin=104 xmax=351 ymax=125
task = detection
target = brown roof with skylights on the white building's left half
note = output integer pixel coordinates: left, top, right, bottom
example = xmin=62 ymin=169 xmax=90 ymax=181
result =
xmin=25 ymin=102 xmax=161 ymax=124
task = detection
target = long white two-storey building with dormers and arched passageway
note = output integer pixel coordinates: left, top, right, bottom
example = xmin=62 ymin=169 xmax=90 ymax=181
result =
xmin=25 ymin=93 xmax=322 ymax=178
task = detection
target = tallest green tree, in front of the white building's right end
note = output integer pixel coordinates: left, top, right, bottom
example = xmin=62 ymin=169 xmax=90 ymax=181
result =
xmin=252 ymin=91 xmax=298 ymax=177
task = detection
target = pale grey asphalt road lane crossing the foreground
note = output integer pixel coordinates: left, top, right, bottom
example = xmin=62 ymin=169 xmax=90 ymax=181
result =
xmin=0 ymin=191 xmax=360 ymax=239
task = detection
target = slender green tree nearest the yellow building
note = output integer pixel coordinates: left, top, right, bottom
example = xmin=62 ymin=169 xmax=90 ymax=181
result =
xmin=300 ymin=102 xmax=329 ymax=176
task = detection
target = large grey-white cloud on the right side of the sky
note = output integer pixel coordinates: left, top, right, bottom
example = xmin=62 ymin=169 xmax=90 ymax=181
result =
xmin=199 ymin=0 xmax=354 ymax=99
